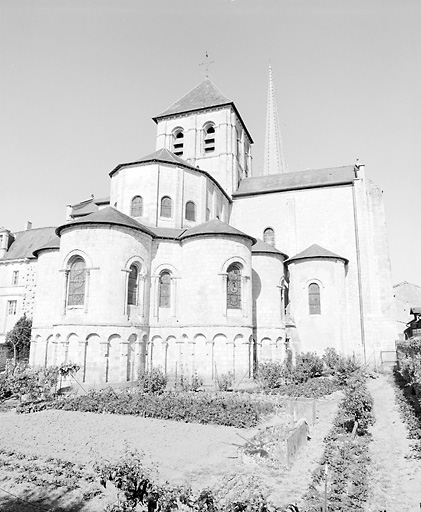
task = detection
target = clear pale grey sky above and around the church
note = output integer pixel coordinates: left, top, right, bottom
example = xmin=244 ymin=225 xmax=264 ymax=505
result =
xmin=0 ymin=0 xmax=421 ymax=285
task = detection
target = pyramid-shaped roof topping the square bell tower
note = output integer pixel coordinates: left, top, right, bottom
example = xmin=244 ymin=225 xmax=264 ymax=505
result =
xmin=152 ymin=77 xmax=253 ymax=143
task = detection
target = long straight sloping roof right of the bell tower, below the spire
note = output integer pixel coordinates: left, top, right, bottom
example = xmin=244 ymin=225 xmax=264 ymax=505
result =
xmin=233 ymin=165 xmax=355 ymax=197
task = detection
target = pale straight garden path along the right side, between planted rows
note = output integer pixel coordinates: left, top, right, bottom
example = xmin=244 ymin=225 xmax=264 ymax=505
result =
xmin=366 ymin=374 xmax=421 ymax=512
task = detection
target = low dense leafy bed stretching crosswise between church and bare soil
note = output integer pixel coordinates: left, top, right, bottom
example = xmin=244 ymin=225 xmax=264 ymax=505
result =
xmin=17 ymin=388 xmax=275 ymax=428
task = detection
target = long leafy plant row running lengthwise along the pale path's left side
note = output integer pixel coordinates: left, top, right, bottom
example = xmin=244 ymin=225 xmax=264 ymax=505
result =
xmin=305 ymin=372 xmax=374 ymax=512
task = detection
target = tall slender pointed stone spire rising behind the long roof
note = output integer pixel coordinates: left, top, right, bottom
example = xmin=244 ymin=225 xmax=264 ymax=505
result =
xmin=263 ymin=64 xmax=287 ymax=175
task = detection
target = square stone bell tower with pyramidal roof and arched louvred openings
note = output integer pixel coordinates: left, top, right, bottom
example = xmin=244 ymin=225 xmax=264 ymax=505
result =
xmin=153 ymin=77 xmax=253 ymax=195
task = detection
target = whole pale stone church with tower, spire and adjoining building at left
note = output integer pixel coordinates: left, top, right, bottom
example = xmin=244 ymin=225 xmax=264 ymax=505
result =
xmin=0 ymin=71 xmax=396 ymax=386
